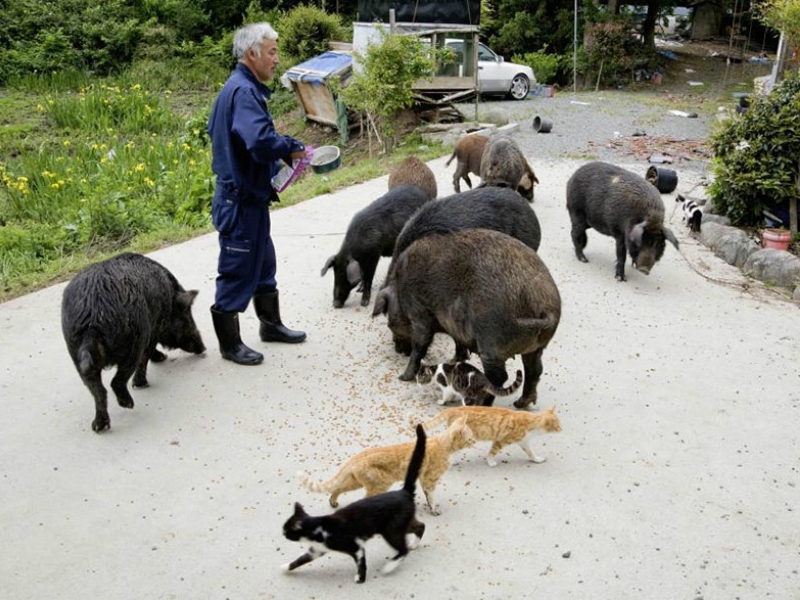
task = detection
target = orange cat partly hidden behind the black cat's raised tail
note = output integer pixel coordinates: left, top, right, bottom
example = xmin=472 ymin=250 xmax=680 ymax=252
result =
xmin=298 ymin=417 xmax=475 ymax=515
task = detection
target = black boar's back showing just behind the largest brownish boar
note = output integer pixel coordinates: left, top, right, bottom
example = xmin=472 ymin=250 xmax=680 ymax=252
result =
xmin=389 ymin=187 xmax=542 ymax=282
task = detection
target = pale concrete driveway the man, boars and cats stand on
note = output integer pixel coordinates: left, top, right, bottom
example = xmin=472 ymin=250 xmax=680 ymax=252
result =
xmin=0 ymin=158 xmax=800 ymax=600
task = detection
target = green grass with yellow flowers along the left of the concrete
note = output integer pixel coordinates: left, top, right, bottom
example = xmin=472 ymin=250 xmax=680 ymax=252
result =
xmin=0 ymin=67 xmax=444 ymax=301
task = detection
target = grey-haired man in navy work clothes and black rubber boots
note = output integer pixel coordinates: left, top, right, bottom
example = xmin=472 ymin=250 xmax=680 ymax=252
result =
xmin=208 ymin=23 xmax=306 ymax=365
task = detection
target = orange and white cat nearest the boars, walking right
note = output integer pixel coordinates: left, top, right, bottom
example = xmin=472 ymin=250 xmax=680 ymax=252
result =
xmin=424 ymin=406 xmax=561 ymax=467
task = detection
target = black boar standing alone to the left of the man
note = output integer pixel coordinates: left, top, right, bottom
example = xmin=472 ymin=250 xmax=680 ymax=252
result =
xmin=61 ymin=253 xmax=206 ymax=432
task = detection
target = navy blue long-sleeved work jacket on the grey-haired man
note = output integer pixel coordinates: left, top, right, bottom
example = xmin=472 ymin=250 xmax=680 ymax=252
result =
xmin=208 ymin=63 xmax=303 ymax=203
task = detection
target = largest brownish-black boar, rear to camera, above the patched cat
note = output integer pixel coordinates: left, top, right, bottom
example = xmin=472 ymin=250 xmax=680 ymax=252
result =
xmin=372 ymin=229 xmax=561 ymax=408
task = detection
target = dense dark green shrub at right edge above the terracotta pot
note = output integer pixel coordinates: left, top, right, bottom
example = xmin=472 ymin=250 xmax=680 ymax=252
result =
xmin=708 ymin=77 xmax=800 ymax=225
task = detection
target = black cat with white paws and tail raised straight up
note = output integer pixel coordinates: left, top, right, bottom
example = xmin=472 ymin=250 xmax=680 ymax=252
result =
xmin=283 ymin=425 xmax=426 ymax=583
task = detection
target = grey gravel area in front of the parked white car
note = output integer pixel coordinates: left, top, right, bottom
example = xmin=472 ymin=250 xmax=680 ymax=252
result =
xmin=458 ymin=91 xmax=715 ymax=176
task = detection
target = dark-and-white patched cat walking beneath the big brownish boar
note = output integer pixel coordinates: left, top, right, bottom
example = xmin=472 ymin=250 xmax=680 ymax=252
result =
xmin=417 ymin=361 xmax=522 ymax=406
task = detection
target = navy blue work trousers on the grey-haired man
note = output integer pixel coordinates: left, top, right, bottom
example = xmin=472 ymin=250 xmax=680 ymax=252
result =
xmin=211 ymin=194 xmax=277 ymax=312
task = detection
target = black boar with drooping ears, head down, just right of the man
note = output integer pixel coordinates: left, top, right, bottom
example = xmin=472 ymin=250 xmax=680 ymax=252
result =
xmin=321 ymin=184 xmax=430 ymax=308
